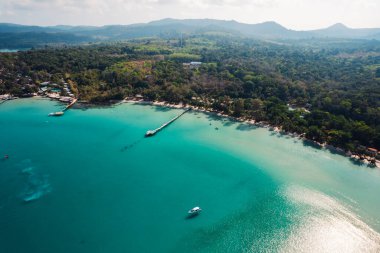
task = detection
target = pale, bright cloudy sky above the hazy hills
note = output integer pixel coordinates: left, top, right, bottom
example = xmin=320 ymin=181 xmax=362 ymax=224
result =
xmin=0 ymin=0 xmax=380 ymax=30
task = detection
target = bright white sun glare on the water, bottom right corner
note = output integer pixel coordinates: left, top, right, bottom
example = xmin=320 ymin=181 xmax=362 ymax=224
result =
xmin=281 ymin=186 xmax=380 ymax=252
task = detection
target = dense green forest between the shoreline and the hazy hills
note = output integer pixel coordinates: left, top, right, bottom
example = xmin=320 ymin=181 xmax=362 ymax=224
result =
xmin=0 ymin=34 xmax=380 ymax=153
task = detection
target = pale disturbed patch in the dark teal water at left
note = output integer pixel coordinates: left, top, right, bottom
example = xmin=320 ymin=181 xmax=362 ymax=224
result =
xmin=21 ymin=167 xmax=51 ymax=202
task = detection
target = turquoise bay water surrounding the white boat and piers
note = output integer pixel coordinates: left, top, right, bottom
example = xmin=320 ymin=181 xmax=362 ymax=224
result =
xmin=0 ymin=98 xmax=380 ymax=253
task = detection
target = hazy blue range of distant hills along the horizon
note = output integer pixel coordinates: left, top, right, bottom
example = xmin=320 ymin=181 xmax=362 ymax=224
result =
xmin=0 ymin=19 xmax=380 ymax=49
